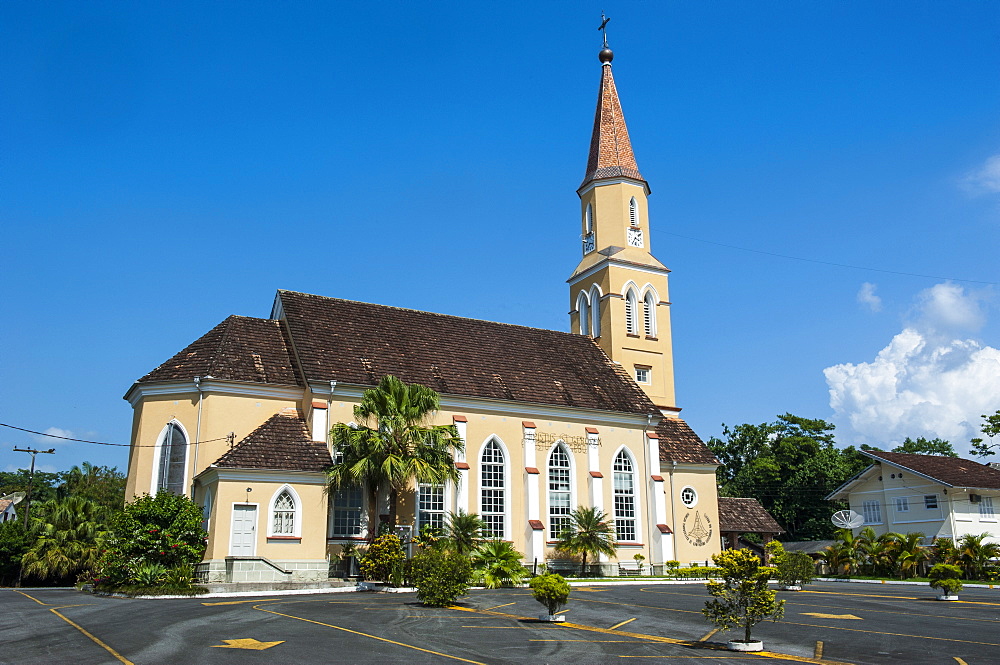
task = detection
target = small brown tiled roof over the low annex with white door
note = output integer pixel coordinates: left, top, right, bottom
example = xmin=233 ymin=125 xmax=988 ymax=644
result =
xmin=215 ymin=409 xmax=333 ymax=471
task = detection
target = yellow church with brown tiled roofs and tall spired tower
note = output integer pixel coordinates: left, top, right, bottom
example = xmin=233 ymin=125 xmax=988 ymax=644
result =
xmin=125 ymin=42 xmax=722 ymax=582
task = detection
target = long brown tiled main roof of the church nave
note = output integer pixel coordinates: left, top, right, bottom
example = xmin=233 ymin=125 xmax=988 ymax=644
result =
xmin=278 ymin=291 xmax=660 ymax=416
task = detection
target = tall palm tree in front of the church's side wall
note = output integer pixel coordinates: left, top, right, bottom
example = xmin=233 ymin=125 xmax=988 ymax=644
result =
xmin=327 ymin=375 xmax=464 ymax=539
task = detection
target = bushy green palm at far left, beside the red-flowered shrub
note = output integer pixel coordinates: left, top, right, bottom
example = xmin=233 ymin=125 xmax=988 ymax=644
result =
xmin=21 ymin=496 xmax=107 ymax=579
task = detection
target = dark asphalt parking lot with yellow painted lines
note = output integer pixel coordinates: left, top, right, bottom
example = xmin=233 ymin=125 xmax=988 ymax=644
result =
xmin=0 ymin=583 xmax=1000 ymax=665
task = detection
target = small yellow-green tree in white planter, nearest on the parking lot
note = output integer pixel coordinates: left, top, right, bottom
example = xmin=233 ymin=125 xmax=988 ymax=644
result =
xmin=702 ymin=549 xmax=785 ymax=651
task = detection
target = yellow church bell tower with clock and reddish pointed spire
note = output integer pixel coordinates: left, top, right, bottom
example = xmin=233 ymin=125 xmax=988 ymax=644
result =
xmin=567 ymin=42 xmax=678 ymax=416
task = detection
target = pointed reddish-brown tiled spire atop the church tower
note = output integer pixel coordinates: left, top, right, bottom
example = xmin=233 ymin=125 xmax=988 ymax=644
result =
xmin=580 ymin=47 xmax=649 ymax=189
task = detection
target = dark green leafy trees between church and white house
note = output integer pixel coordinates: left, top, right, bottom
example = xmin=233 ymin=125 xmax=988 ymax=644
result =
xmin=708 ymin=413 xmax=870 ymax=540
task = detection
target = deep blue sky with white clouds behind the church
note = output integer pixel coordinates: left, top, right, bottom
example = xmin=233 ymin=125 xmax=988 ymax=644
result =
xmin=0 ymin=1 xmax=1000 ymax=469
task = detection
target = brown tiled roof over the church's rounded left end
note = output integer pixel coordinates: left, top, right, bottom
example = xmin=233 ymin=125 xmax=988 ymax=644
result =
xmin=139 ymin=316 xmax=299 ymax=385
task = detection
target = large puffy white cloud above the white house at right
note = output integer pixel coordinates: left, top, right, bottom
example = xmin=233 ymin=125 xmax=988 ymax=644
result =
xmin=823 ymin=283 xmax=1000 ymax=452
